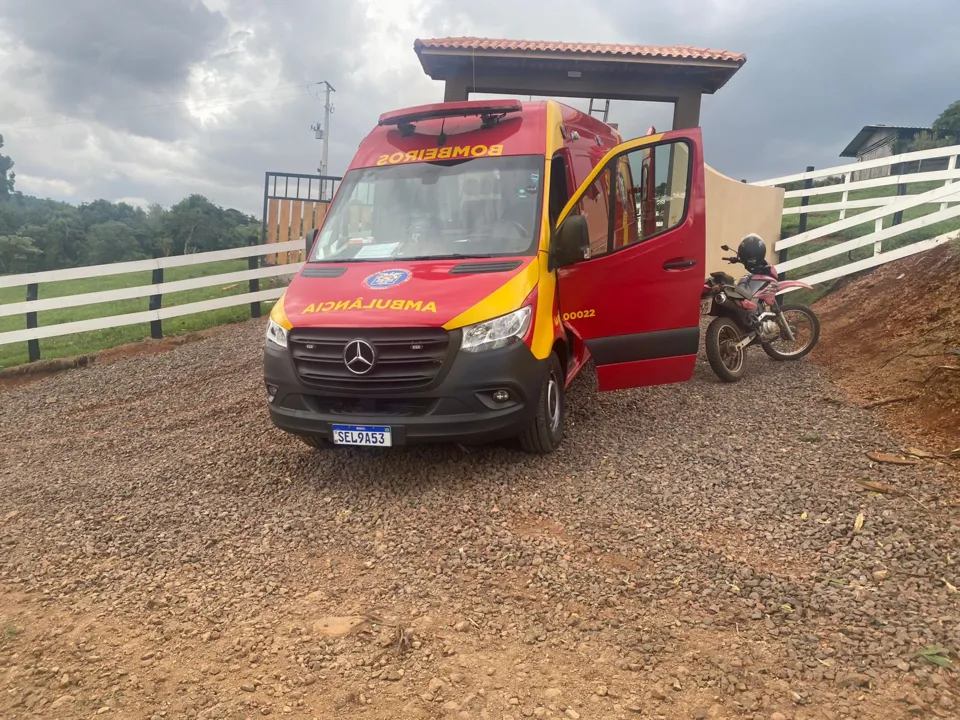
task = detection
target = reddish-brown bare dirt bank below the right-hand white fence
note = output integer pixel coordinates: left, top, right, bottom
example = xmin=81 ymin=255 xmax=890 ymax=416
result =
xmin=811 ymin=244 xmax=960 ymax=450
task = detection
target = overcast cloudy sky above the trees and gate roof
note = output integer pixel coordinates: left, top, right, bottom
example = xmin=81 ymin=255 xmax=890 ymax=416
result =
xmin=0 ymin=0 xmax=960 ymax=215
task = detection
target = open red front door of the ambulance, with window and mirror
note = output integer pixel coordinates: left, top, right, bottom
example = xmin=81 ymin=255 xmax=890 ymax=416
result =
xmin=550 ymin=128 xmax=706 ymax=390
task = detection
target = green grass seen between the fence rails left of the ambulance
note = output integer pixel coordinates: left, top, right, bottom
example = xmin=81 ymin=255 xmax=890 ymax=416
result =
xmin=0 ymin=260 xmax=282 ymax=368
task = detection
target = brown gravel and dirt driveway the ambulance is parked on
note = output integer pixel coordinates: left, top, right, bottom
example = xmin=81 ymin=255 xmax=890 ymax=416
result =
xmin=0 ymin=321 xmax=960 ymax=720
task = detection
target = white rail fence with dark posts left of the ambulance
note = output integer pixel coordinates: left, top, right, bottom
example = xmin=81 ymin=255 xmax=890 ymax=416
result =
xmin=0 ymin=240 xmax=305 ymax=360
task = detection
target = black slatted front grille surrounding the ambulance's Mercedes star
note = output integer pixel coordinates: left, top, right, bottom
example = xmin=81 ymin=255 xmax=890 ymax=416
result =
xmin=288 ymin=328 xmax=459 ymax=391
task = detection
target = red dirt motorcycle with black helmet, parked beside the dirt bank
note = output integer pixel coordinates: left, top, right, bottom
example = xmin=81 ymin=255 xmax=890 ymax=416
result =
xmin=700 ymin=235 xmax=820 ymax=382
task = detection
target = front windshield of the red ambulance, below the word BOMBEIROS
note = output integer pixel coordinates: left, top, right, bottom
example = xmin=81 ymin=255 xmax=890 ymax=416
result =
xmin=310 ymin=155 xmax=544 ymax=262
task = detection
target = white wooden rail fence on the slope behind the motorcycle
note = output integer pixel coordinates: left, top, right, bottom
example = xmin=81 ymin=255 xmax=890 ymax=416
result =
xmin=754 ymin=145 xmax=960 ymax=292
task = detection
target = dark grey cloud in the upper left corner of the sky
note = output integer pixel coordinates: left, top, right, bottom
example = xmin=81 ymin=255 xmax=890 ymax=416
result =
xmin=0 ymin=0 xmax=227 ymax=140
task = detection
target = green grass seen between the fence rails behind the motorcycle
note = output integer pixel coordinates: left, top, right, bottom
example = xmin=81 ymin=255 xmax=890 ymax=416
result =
xmin=781 ymin=181 xmax=960 ymax=304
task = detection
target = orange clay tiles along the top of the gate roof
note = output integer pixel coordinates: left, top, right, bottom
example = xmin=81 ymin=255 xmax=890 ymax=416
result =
xmin=414 ymin=37 xmax=747 ymax=65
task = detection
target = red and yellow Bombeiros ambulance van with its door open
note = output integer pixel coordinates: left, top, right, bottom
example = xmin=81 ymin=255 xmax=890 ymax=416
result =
xmin=264 ymin=100 xmax=705 ymax=453
